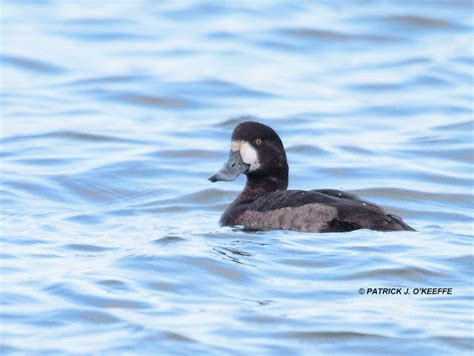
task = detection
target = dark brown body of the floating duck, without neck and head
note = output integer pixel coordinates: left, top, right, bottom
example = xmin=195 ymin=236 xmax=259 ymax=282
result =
xmin=221 ymin=189 xmax=413 ymax=232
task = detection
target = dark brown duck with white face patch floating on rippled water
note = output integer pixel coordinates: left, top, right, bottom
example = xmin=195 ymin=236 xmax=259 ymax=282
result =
xmin=209 ymin=121 xmax=415 ymax=232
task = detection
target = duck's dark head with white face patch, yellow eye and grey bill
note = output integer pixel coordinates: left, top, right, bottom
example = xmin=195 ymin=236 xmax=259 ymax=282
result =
xmin=209 ymin=121 xmax=288 ymax=189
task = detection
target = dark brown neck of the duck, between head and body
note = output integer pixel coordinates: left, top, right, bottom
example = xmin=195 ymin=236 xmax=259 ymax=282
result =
xmin=235 ymin=168 xmax=288 ymax=203
